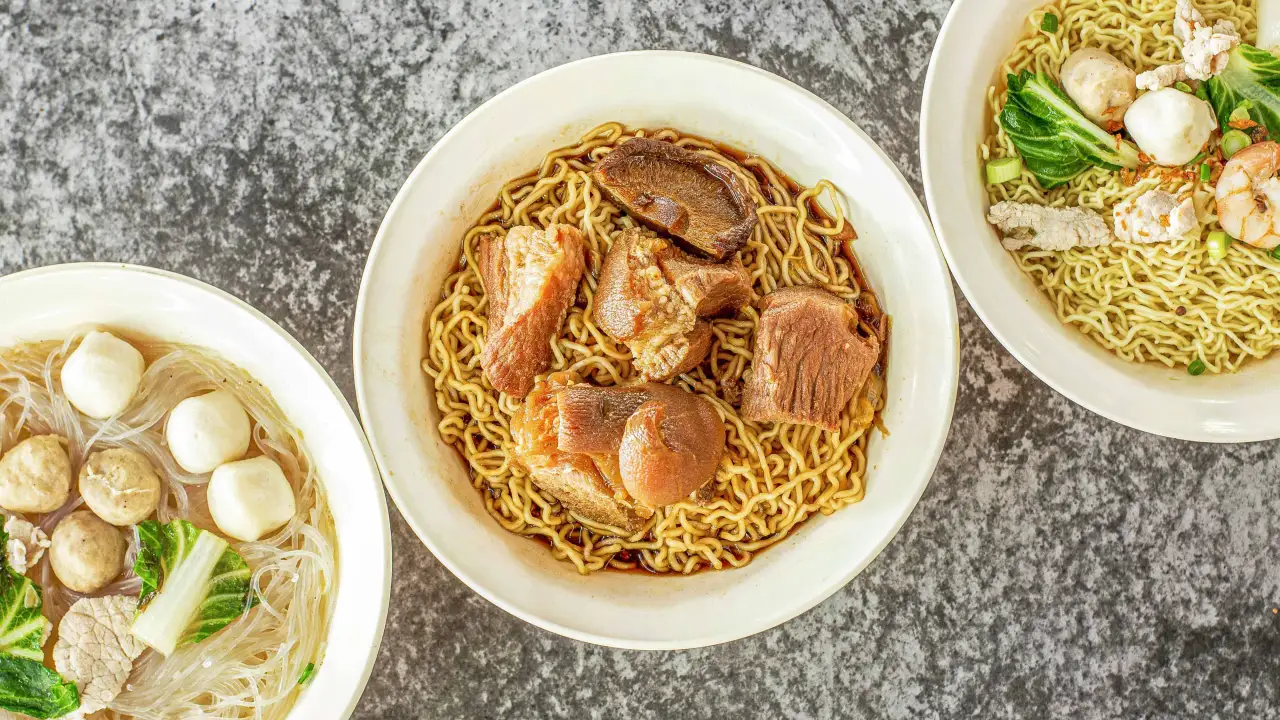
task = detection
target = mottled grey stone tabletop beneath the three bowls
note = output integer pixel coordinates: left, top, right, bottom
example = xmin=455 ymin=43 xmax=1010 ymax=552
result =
xmin=0 ymin=0 xmax=1280 ymax=720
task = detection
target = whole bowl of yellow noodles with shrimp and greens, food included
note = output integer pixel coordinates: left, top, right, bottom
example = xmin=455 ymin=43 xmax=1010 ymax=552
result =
xmin=920 ymin=0 xmax=1280 ymax=442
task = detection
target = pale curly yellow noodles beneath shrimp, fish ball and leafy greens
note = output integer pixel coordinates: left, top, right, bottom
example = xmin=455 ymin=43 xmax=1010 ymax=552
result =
xmin=982 ymin=0 xmax=1280 ymax=373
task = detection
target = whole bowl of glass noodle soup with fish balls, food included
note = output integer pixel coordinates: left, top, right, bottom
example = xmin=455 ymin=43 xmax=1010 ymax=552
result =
xmin=0 ymin=264 xmax=390 ymax=719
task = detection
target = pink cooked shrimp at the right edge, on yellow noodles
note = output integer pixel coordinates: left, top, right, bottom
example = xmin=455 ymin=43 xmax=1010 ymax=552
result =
xmin=1215 ymin=142 xmax=1280 ymax=250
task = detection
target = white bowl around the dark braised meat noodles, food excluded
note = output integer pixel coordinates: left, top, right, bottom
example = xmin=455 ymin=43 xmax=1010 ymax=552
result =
xmin=355 ymin=53 xmax=957 ymax=648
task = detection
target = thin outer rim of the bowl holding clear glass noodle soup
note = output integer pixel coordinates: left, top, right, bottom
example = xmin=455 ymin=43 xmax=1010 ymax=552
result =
xmin=0 ymin=261 xmax=393 ymax=717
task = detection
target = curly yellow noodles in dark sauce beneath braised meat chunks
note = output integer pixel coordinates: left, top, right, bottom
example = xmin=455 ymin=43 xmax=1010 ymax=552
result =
xmin=422 ymin=123 xmax=885 ymax=574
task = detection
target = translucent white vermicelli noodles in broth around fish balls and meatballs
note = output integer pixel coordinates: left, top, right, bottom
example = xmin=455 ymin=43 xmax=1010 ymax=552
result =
xmin=0 ymin=334 xmax=337 ymax=720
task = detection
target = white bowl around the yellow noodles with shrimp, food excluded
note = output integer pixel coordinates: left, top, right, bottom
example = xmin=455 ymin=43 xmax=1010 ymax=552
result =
xmin=920 ymin=0 xmax=1280 ymax=442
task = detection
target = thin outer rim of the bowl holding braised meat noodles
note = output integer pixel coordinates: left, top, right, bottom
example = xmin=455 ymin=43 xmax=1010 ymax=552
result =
xmin=352 ymin=50 xmax=960 ymax=651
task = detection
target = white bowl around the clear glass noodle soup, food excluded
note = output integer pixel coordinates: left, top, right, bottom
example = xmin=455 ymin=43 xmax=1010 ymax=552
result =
xmin=0 ymin=263 xmax=392 ymax=720
